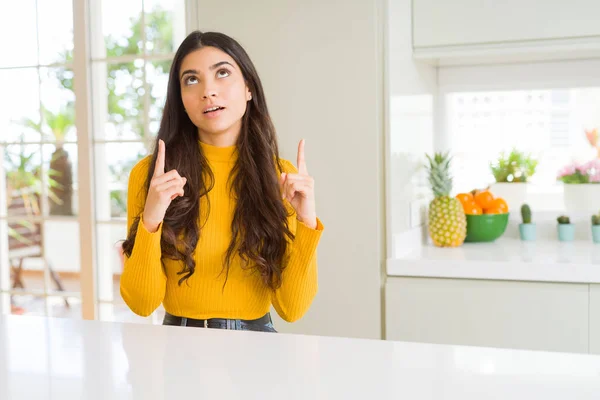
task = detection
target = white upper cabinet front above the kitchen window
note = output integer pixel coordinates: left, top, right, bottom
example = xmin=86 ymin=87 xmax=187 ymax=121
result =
xmin=412 ymin=0 xmax=600 ymax=48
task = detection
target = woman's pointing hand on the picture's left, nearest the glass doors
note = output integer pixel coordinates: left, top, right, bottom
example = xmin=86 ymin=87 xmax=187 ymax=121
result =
xmin=142 ymin=140 xmax=187 ymax=232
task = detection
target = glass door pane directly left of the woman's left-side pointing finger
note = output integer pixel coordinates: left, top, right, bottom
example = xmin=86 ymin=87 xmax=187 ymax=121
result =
xmin=95 ymin=143 xmax=148 ymax=221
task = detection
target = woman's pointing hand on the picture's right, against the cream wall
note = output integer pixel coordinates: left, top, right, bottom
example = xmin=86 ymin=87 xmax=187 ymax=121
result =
xmin=279 ymin=139 xmax=317 ymax=229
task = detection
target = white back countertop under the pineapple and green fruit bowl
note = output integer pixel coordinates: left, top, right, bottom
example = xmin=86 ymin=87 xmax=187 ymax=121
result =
xmin=387 ymin=238 xmax=600 ymax=283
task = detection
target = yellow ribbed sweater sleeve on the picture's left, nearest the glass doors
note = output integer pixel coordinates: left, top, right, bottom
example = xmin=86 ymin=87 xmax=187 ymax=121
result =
xmin=120 ymin=157 xmax=167 ymax=317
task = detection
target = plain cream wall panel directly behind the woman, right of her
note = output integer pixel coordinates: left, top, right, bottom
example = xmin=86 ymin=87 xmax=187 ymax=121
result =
xmin=198 ymin=0 xmax=383 ymax=338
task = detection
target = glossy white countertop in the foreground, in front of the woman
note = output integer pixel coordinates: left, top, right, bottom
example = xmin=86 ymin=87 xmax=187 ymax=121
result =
xmin=0 ymin=316 xmax=600 ymax=400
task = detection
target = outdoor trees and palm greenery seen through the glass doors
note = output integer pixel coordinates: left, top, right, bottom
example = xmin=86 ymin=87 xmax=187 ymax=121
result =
xmin=5 ymin=8 xmax=175 ymax=225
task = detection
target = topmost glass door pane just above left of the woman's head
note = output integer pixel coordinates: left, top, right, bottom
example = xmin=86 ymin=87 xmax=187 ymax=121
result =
xmin=144 ymin=0 xmax=186 ymax=54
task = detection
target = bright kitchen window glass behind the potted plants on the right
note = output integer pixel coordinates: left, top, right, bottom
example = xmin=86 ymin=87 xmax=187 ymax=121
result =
xmin=447 ymin=87 xmax=600 ymax=194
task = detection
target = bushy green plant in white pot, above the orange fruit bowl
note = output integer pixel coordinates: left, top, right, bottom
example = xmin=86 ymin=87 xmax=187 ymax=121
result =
xmin=490 ymin=149 xmax=538 ymax=210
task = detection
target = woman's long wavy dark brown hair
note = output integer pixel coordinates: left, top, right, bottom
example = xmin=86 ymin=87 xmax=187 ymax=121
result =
xmin=123 ymin=31 xmax=293 ymax=289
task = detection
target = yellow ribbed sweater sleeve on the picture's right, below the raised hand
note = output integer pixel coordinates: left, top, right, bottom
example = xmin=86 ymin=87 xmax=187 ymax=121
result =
xmin=271 ymin=162 xmax=324 ymax=322
